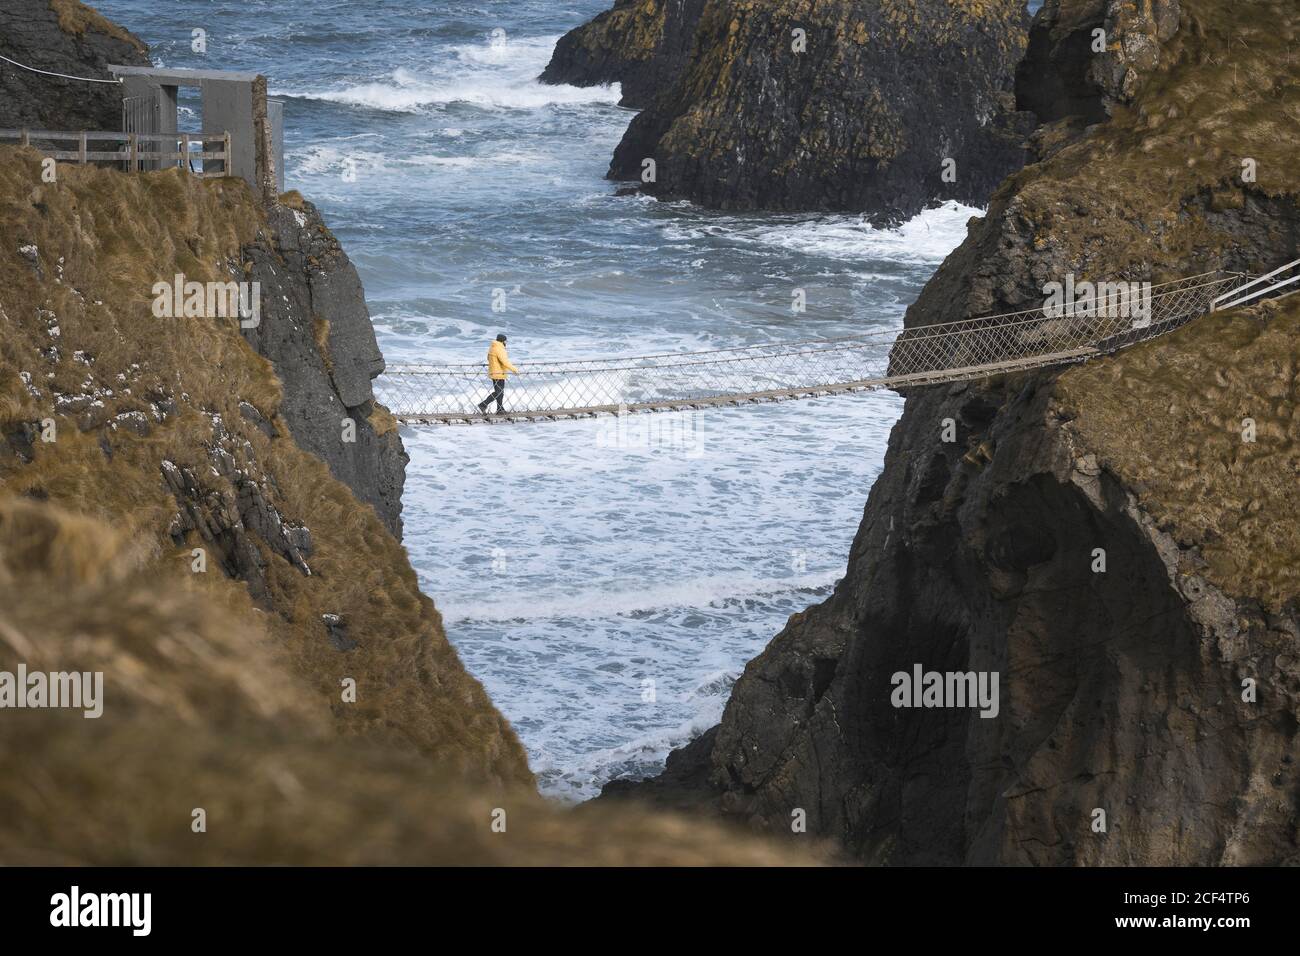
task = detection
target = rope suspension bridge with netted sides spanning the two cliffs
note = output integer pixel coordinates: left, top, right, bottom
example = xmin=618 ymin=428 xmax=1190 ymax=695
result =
xmin=376 ymin=260 xmax=1300 ymax=424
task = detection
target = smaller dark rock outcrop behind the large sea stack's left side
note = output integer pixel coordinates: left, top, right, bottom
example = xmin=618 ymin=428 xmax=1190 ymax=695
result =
xmin=540 ymin=0 xmax=705 ymax=109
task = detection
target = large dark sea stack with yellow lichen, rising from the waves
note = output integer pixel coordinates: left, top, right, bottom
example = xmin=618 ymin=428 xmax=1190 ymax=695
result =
xmin=593 ymin=0 xmax=1030 ymax=221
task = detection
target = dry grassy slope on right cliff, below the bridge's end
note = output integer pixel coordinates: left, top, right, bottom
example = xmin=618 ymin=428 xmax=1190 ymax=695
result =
xmin=1058 ymin=297 xmax=1300 ymax=611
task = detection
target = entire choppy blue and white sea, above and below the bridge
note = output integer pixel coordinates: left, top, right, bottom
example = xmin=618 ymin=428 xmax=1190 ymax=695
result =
xmin=98 ymin=0 xmax=1024 ymax=800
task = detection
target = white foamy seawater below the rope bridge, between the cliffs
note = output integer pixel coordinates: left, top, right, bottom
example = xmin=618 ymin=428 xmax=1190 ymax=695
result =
xmin=404 ymin=393 xmax=900 ymax=800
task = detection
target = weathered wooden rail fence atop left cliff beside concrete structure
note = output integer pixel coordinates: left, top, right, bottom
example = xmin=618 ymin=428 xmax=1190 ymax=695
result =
xmin=0 ymin=129 xmax=230 ymax=177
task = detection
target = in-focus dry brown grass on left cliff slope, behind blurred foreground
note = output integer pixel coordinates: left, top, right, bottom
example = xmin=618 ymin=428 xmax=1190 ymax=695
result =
xmin=0 ymin=148 xmax=532 ymax=787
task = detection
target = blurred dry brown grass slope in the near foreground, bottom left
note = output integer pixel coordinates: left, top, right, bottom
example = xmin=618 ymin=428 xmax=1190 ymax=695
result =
xmin=0 ymin=497 xmax=816 ymax=865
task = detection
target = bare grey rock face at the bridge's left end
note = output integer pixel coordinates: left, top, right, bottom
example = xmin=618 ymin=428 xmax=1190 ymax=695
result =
xmin=243 ymin=194 xmax=408 ymax=538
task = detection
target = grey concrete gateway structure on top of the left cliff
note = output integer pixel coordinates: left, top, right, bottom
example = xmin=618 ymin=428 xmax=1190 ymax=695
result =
xmin=108 ymin=65 xmax=285 ymax=199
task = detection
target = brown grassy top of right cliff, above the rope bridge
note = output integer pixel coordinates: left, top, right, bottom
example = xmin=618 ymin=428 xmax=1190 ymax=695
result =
xmin=996 ymin=0 xmax=1300 ymax=280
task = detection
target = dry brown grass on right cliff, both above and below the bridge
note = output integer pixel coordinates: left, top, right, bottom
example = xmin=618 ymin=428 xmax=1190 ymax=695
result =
xmin=1029 ymin=0 xmax=1300 ymax=610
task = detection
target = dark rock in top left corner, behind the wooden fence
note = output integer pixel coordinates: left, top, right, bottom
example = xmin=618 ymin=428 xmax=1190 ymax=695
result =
xmin=0 ymin=0 xmax=150 ymax=130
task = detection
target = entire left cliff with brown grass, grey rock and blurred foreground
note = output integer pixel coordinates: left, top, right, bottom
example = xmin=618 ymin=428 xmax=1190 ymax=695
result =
xmin=0 ymin=0 xmax=813 ymax=865
